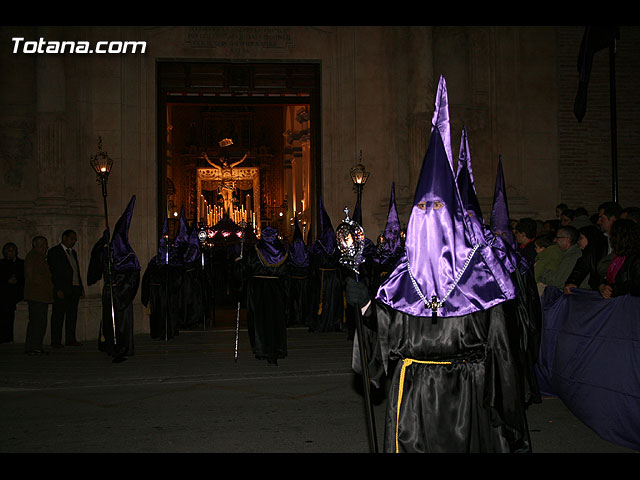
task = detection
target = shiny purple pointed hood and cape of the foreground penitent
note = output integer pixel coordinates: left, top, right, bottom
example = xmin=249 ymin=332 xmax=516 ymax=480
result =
xmin=376 ymin=77 xmax=515 ymax=317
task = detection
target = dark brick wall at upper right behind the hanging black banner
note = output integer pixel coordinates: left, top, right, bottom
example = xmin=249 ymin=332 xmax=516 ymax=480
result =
xmin=558 ymin=26 xmax=640 ymax=213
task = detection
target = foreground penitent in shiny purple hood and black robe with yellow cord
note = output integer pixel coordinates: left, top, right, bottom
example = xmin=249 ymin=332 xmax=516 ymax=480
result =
xmin=347 ymin=77 xmax=530 ymax=453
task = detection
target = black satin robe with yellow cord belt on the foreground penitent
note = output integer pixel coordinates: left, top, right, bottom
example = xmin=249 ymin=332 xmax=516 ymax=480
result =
xmin=353 ymin=302 xmax=528 ymax=453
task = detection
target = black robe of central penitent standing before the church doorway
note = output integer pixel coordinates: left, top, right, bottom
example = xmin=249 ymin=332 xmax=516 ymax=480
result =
xmin=239 ymin=247 xmax=290 ymax=361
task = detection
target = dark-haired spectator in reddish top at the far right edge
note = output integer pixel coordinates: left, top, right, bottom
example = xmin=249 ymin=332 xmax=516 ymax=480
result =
xmin=599 ymin=218 xmax=640 ymax=298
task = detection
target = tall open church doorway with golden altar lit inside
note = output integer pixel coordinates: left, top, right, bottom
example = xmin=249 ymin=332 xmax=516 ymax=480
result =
xmin=157 ymin=61 xmax=321 ymax=328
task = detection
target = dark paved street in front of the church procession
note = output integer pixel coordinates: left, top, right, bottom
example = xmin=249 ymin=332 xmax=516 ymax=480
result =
xmin=0 ymin=328 xmax=631 ymax=453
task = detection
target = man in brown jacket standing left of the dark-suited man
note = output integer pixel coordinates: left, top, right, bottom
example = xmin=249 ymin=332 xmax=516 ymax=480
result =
xmin=24 ymin=236 xmax=53 ymax=355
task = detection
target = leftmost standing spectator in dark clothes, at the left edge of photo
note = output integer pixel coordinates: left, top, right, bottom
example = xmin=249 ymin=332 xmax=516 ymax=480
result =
xmin=0 ymin=242 xmax=24 ymax=343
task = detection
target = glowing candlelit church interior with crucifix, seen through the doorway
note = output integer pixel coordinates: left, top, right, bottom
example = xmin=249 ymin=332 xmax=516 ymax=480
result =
xmin=165 ymin=103 xmax=312 ymax=242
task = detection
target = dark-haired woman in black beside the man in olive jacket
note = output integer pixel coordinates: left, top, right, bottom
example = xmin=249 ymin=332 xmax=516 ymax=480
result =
xmin=564 ymin=225 xmax=608 ymax=293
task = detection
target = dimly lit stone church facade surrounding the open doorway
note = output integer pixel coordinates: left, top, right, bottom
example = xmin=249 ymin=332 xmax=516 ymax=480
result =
xmin=0 ymin=26 xmax=640 ymax=341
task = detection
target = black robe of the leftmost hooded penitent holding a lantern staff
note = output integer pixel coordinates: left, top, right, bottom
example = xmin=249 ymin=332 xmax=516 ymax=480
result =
xmin=87 ymin=242 xmax=140 ymax=357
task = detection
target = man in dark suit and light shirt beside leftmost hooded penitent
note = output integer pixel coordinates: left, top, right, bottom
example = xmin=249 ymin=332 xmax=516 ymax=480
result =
xmin=47 ymin=230 xmax=84 ymax=347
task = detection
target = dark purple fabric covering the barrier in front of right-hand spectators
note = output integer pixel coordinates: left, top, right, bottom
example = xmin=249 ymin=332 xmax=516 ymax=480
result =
xmin=536 ymin=287 xmax=640 ymax=450
